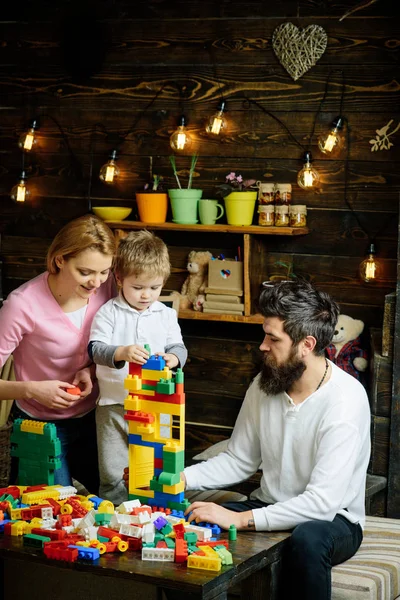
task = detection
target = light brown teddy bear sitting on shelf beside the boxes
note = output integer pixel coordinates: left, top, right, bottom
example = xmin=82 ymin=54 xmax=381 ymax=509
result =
xmin=179 ymin=250 xmax=213 ymax=311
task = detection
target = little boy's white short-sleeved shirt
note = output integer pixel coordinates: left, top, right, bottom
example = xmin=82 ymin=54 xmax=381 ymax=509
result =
xmin=90 ymin=296 xmax=183 ymax=405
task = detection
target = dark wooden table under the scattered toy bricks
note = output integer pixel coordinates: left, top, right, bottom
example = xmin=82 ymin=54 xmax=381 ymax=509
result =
xmin=0 ymin=532 xmax=289 ymax=600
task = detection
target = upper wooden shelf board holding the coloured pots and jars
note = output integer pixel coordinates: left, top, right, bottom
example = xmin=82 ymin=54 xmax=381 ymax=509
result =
xmin=105 ymin=221 xmax=310 ymax=235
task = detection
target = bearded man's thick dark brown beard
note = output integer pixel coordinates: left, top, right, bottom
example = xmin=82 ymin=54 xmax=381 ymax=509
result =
xmin=258 ymin=348 xmax=306 ymax=395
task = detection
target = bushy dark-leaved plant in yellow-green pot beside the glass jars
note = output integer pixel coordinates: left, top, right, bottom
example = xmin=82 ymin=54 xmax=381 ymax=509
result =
xmin=217 ymin=171 xmax=257 ymax=225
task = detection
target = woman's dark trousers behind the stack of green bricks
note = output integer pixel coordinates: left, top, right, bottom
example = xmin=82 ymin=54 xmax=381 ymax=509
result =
xmin=10 ymin=402 xmax=100 ymax=495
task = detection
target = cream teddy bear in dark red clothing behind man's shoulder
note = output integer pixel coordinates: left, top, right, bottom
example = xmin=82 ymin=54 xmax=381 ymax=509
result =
xmin=325 ymin=315 xmax=368 ymax=383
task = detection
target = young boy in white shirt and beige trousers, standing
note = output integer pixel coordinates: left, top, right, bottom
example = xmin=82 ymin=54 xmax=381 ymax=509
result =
xmin=89 ymin=230 xmax=187 ymax=506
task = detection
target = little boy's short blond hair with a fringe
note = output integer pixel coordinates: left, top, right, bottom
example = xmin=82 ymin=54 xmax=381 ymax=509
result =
xmin=115 ymin=229 xmax=171 ymax=283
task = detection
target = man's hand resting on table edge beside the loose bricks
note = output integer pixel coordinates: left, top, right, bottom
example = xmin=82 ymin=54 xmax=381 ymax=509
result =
xmin=185 ymin=502 xmax=255 ymax=530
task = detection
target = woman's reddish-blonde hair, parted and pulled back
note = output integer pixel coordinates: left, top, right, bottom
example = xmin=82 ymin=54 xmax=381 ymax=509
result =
xmin=47 ymin=215 xmax=116 ymax=275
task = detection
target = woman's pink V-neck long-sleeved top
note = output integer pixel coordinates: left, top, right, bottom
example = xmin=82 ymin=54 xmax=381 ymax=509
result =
xmin=0 ymin=272 xmax=116 ymax=420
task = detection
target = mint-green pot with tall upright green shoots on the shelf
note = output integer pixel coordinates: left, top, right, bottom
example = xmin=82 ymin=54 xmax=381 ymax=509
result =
xmin=168 ymin=154 xmax=203 ymax=225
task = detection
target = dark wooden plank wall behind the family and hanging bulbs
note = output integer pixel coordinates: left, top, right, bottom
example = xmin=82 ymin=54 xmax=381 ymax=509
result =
xmin=0 ymin=0 xmax=400 ymax=492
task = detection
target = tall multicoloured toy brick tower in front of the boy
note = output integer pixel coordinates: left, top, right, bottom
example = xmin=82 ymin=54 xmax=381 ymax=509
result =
xmin=124 ymin=355 xmax=189 ymax=510
